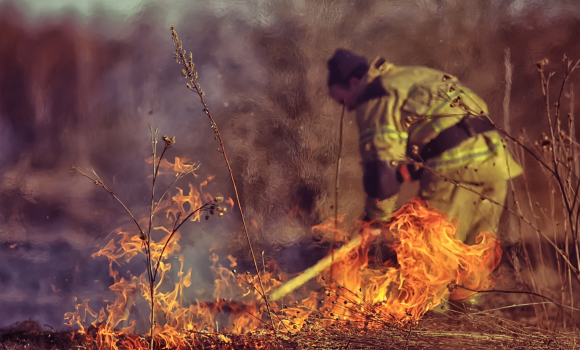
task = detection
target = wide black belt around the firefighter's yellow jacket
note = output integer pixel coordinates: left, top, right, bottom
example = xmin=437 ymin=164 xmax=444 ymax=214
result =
xmin=407 ymin=117 xmax=495 ymax=161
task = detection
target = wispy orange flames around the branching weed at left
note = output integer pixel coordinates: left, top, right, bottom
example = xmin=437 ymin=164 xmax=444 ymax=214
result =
xmin=65 ymin=157 xmax=221 ymax=349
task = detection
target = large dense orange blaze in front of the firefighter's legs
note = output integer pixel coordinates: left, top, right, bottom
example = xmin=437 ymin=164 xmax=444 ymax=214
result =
xmin=322 ymin=199 xmax=502 ymax=321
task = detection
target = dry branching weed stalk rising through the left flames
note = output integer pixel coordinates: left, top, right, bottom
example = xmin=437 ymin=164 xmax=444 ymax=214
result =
xmin=73 ymin=128 xmax=227 ymax=350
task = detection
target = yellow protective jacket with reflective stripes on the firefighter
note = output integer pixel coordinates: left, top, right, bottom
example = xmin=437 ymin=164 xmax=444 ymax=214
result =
xmin=356 ymin=57 xmax=522 ymax=220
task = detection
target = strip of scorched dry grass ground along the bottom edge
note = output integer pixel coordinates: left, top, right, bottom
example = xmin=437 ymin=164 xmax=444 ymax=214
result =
xmin=0 ymin=312 xmax=579 ymax=350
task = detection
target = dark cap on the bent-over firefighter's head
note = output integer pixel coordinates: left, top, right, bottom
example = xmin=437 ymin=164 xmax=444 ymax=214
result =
xmin=328 ymin=49 xmax=369 ymax=87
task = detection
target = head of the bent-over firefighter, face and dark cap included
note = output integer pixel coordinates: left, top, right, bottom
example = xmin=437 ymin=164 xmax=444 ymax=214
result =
xmin=328 ymin=49 xmax=369 ymax=111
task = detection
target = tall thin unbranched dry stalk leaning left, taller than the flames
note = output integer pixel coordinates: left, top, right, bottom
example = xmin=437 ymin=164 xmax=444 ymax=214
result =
xmin=171 ymin=26 xmax=276 ymax=340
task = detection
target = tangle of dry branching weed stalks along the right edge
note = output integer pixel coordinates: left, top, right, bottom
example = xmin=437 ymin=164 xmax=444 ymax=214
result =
xmin=504 ymin=56 xmax=580 ymax=328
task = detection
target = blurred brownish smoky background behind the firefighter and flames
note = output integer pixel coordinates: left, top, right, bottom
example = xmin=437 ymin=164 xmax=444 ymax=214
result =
xmin=0 ymin=0 xmax=580 ymax=329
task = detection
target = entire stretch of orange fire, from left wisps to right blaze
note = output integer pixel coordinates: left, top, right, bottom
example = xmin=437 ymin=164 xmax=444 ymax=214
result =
xmin=65 ymin=158 xmax=501 ymax=349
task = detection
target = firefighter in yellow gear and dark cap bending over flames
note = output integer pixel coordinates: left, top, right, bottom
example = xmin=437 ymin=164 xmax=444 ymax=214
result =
xmin=328 ymin=50 xmax=522 ymax=245
